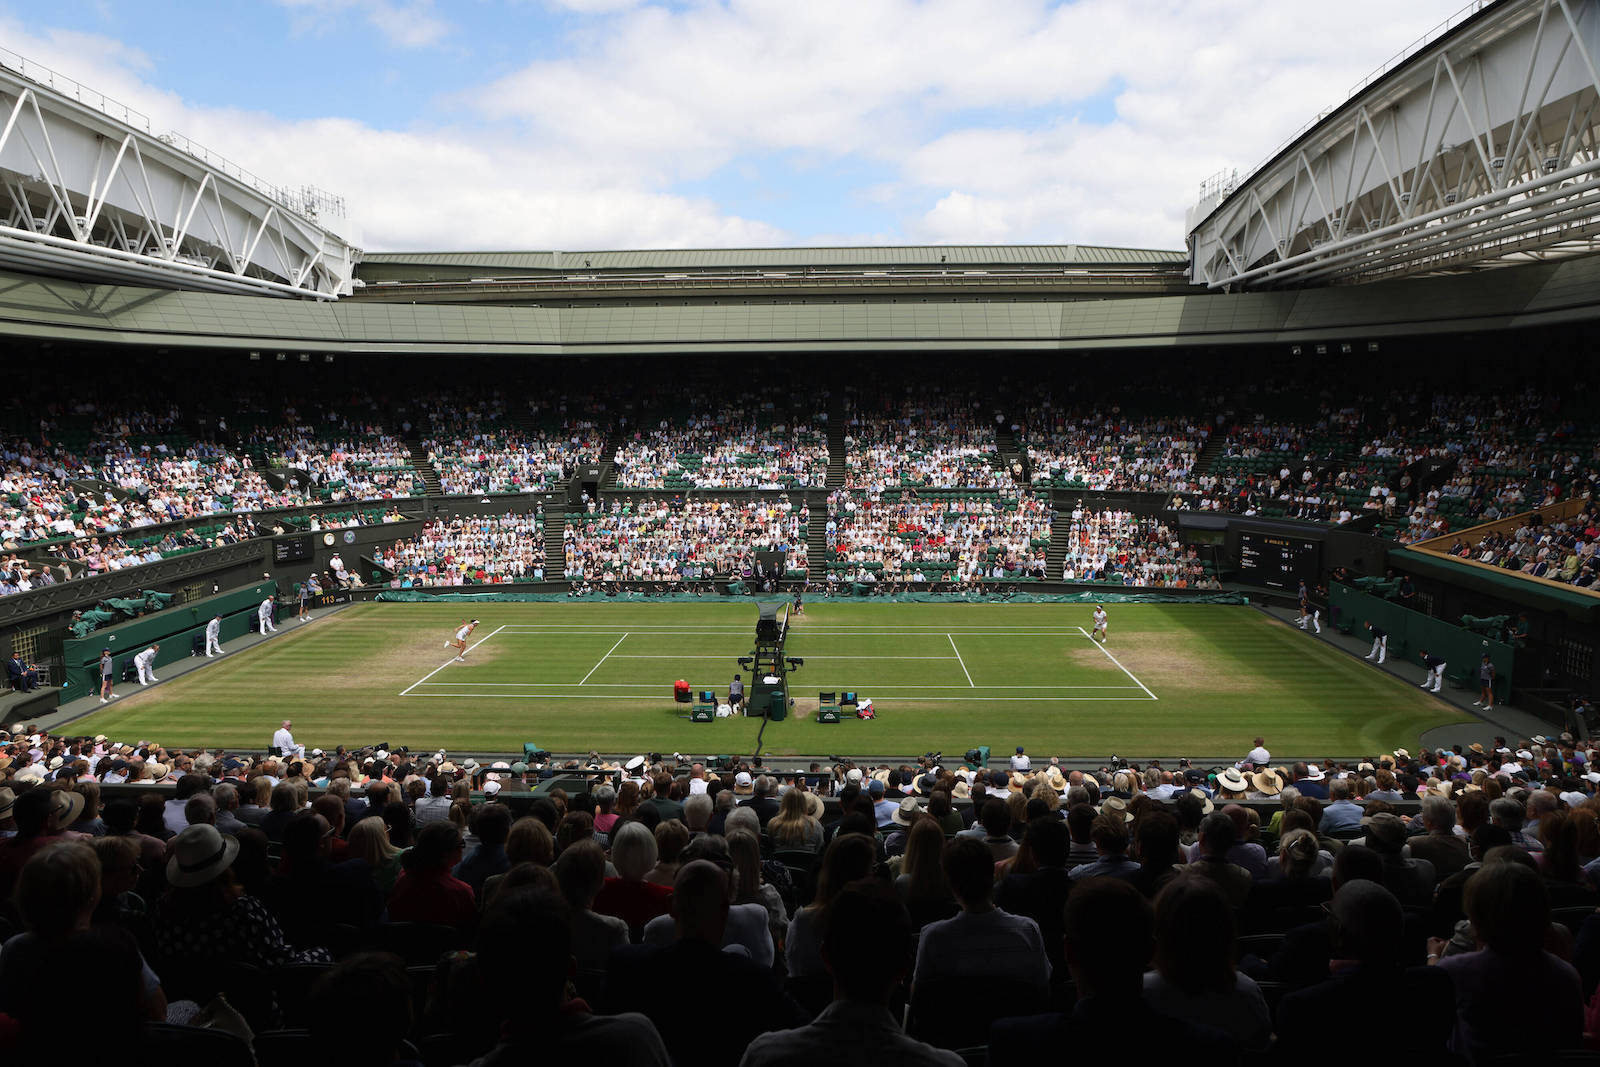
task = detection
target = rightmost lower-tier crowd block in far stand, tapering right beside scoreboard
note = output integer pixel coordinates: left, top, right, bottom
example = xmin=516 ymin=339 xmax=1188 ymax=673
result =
xmin=1061 ymin=501 xmax=1221 ymax=589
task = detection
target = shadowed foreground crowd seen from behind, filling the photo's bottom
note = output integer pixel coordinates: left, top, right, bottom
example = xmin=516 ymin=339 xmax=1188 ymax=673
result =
xmin=0 ymin=733 xmax=1600 ymax=1067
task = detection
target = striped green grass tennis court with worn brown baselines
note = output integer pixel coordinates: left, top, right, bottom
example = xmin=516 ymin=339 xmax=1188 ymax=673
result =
xmin=72 ymin=600 xmax=1462 ymax=758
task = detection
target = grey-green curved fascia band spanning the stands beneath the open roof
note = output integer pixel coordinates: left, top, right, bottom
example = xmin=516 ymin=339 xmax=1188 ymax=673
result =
xmin=0 ymin=256 xmax=1600 ymax=360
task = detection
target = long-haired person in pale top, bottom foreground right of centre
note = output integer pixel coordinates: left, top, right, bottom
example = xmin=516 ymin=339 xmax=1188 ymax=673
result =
xmin=1144 ymin=878 xmax=1272 ymax=1049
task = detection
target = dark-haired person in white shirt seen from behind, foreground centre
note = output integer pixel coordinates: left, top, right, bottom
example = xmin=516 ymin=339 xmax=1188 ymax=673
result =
xmin=912 ymin=837 xmax=1050 ymax=987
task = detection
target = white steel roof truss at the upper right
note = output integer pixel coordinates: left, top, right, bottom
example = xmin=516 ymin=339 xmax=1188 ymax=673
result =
xmin=1189 ymin=0 xmax=1600 ymax=290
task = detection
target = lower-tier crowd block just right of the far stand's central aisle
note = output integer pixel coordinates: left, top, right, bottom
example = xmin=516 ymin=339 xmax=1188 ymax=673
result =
xmin=827 ymin=490 xmax=1053 ymax=584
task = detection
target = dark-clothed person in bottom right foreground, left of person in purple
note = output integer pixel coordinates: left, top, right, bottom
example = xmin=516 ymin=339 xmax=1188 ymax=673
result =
xmin=1277 ymin=881 xmax=1454 ymax=1059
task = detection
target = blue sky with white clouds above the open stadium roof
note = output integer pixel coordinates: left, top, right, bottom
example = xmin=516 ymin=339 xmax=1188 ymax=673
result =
xmin=0 ymin=0 xmax=1466 ymax=251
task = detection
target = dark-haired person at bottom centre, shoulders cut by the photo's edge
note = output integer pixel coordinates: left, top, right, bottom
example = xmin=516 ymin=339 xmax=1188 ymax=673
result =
xmin=739 ymin=883 xmax=965 ymax=1067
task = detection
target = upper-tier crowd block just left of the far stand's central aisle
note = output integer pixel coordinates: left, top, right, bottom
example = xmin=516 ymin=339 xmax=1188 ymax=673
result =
xmin=616 ymin=386 xmax=827 ymax=490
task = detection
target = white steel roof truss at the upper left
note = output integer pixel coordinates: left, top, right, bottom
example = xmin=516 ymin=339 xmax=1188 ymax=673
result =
xmin=0 ymin=53 xmax=362 ymax=299
